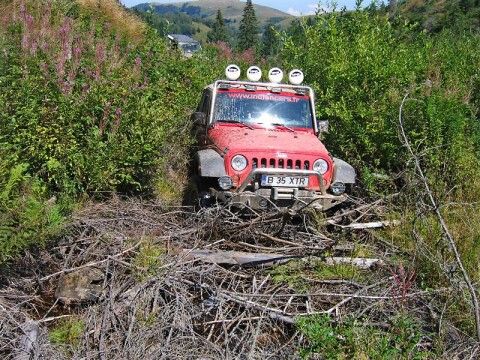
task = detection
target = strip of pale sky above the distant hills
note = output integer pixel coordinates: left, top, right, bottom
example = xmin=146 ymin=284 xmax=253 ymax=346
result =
xmin=121 ymin=0 xmax=366 ymax=16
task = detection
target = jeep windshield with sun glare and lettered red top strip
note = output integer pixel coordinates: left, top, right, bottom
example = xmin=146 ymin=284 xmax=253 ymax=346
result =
xmin=213 ymin=90 xmax=313 ymax=129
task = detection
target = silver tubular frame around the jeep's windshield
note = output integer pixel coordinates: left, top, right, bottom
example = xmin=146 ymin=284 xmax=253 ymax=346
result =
xmin=208 ymin=80 xmax=318 ymax=134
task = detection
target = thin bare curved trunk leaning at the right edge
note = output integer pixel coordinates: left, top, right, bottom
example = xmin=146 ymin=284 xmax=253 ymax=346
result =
xmin=398 ymin=92 xmax=480 ymax=342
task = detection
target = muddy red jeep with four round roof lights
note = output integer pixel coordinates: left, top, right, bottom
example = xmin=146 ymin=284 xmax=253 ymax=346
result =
xmin=192 ymin=65 xmax=355 ymax=210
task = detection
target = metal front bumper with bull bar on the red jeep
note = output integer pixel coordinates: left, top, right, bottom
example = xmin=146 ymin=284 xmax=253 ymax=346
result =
xmin=213 ymin=168 xmax=347 ymax=210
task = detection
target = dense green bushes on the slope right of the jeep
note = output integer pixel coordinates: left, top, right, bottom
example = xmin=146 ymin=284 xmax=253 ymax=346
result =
xmin=282 ymin=11 xmax=480 ymax=197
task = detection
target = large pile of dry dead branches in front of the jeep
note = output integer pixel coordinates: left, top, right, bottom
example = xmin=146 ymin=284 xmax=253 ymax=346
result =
xmin=0 ymin=200 xmax=474 ymax=359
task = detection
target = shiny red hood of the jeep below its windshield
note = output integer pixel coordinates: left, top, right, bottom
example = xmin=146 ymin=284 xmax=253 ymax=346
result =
xmin=209 ymin=124 xmax=328 ymax=156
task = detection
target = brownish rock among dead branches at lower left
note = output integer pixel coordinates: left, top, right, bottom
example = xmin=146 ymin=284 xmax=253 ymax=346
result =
xmin=55 ymin=267 xmax=105 ymax=304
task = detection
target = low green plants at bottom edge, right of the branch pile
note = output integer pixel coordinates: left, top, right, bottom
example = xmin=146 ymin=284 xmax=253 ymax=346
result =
xmin=297 ymin=315 xmax=433 ymax=360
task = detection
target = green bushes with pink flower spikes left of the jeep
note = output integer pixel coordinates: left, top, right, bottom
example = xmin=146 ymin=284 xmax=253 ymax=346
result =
xmin=0 ymin=0 xmax=223 ymax=259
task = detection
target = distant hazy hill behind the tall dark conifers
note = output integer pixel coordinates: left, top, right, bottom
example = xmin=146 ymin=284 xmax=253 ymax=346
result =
xmin=134 ymin=0 xmax=294 ymax=28
